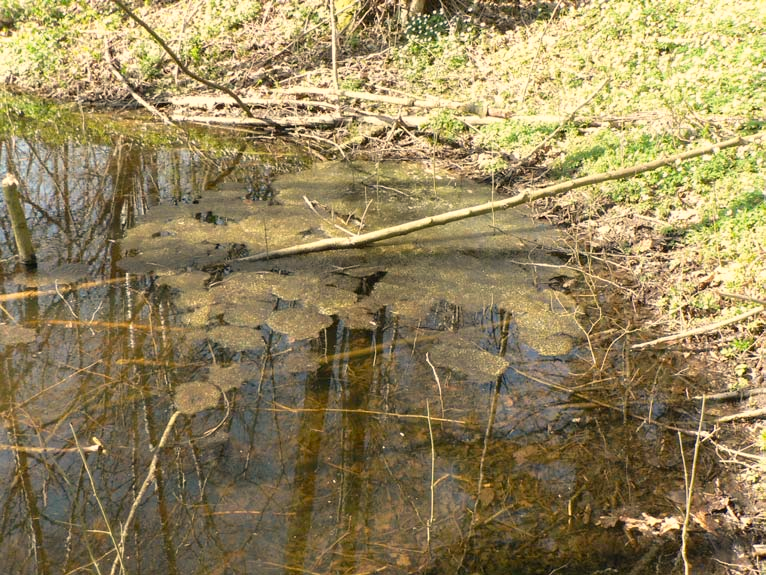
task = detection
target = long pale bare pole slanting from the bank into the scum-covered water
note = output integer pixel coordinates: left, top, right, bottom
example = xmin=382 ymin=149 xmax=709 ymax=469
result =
xmin=237 ymin=132 xmax=766 ymax=261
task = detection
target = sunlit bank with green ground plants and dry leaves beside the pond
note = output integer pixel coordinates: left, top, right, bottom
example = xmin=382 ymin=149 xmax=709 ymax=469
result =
xmin=0 ymin=0 xmax=766 ymax=387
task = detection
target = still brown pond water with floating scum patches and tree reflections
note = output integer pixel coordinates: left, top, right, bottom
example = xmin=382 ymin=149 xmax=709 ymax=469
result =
xmin=0 ymin=119 xmax=744 ymax=575
